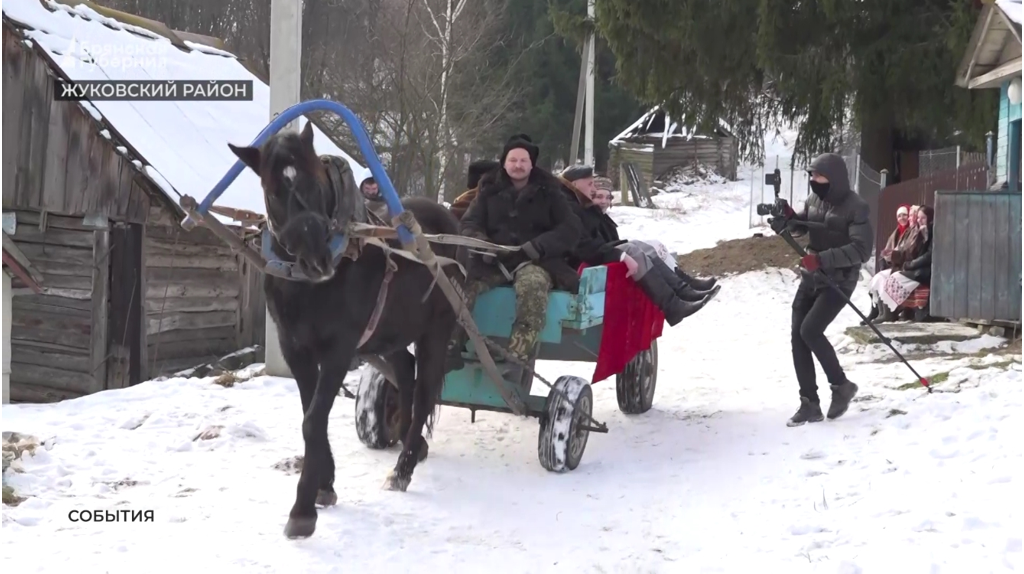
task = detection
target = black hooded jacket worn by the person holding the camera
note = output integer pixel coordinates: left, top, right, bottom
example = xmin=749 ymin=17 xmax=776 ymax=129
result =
xmin=792 ymin=153 xmax=874 ymax=292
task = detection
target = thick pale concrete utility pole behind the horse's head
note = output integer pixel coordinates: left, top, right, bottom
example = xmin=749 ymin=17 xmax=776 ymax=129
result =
xmin=264 ymin=0 xmax=302 ymax=377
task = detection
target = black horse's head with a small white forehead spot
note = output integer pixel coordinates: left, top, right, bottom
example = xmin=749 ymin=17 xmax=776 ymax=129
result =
xmin=227 ymin=122 xmax=337 ymax=282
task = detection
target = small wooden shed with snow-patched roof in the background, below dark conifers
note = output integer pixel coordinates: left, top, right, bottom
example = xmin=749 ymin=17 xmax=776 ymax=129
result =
xmin=608 ymin=106 xmax=739 ymax=189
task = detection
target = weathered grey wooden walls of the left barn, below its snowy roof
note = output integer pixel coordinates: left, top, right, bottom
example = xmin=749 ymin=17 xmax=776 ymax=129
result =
xmin=3 ymin=11 xmax=265 ymax=402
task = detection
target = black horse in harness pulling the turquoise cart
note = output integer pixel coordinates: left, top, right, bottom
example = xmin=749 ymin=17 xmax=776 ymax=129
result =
xmin=228 ymin=123 xmax=462 ymax=538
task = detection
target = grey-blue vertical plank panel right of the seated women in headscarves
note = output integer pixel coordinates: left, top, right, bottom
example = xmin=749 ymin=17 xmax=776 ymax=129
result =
xmin=931 ymin=190 xmax=1021 ymax=322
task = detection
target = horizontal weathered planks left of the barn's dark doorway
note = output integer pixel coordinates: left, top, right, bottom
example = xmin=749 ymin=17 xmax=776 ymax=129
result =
xmin=10 ymin=211 xmax=110 ymax=402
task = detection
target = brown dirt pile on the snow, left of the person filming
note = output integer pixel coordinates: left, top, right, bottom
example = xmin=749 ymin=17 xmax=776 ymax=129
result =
xmin=676 ymin=231 xmax=807 ymax=276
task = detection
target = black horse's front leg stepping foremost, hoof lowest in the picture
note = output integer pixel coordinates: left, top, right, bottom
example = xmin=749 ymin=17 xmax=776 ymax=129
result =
xmin=285 ymin=333 xmax=358 ymax=538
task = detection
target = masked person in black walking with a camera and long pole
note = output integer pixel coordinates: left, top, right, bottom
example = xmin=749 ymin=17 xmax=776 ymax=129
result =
xmin=771 ymin=153 xmax=874 ymax=427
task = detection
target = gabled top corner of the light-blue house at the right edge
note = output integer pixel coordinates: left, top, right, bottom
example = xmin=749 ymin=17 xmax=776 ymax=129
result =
xmin=956 ymin=0 xmax=1024 ymax=192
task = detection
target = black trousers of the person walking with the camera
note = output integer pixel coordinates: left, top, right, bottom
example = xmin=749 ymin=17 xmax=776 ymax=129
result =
xmin=791 ymin=281 xmax=855 ymax=403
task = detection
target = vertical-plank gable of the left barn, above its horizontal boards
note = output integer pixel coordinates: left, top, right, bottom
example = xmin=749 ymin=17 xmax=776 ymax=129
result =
xmin=2 ymin=24 xmax=148 ymax=222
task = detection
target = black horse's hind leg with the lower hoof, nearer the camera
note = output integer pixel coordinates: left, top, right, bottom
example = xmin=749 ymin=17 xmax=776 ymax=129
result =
xmin=386 ymin=329 xmax=451 ymax=492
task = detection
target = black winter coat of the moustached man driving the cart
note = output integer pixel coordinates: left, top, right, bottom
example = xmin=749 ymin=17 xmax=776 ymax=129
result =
xmin=460 ymin=167 xmax=583 ymax=292
